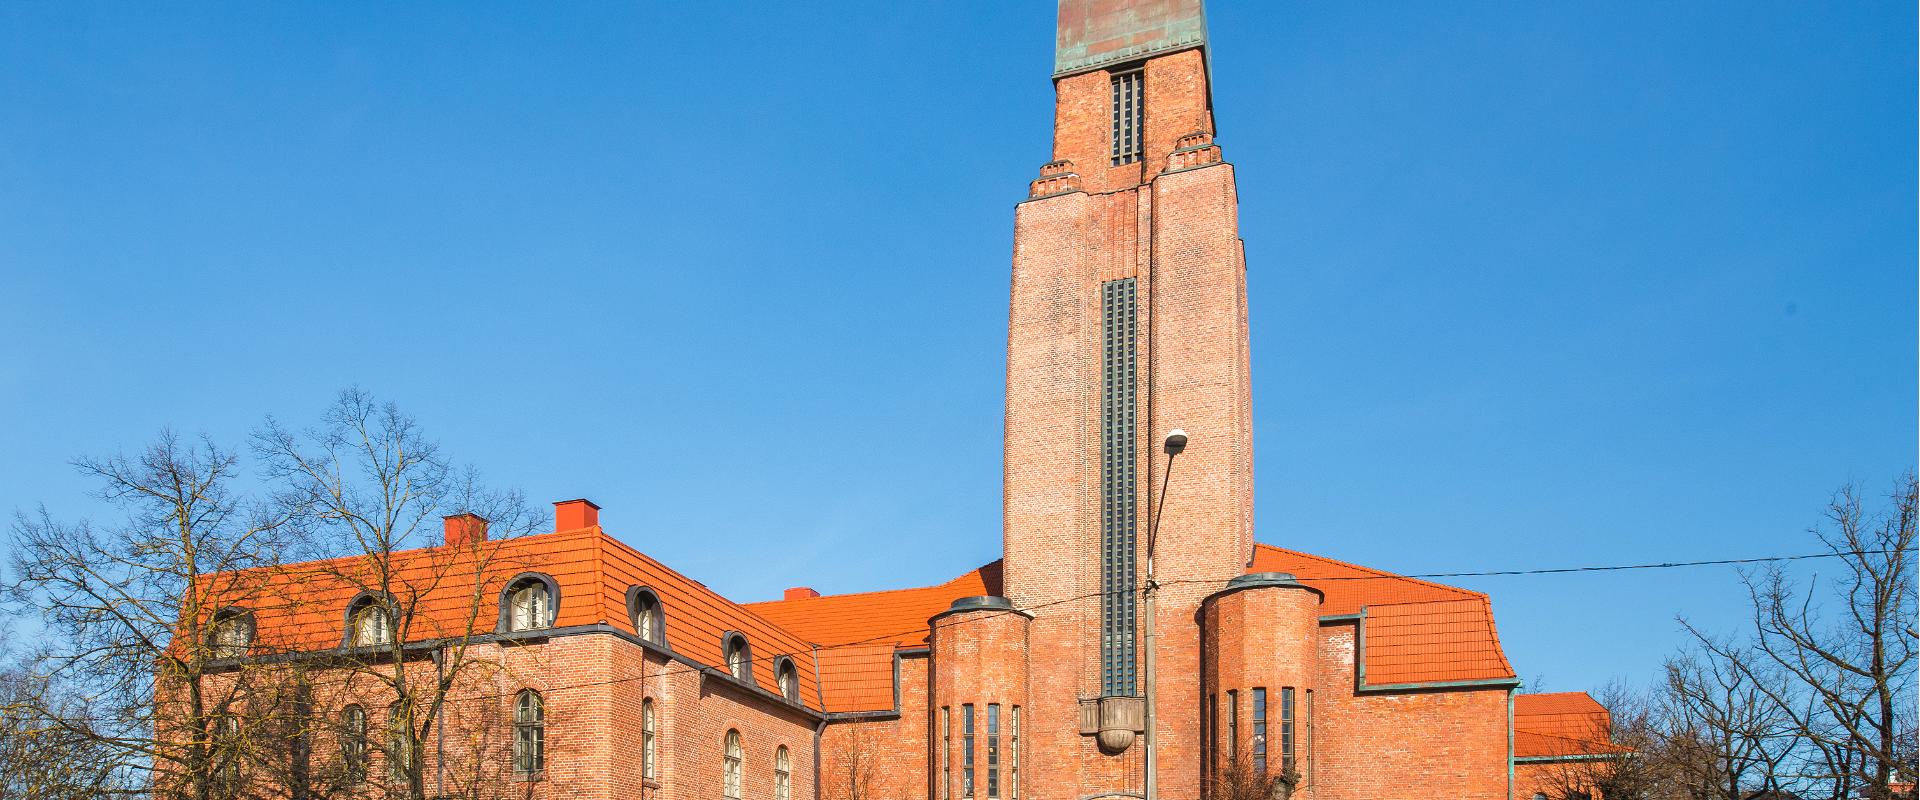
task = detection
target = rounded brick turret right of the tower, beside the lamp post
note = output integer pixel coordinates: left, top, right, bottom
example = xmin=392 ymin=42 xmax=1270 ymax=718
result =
xmin=1200 ymin=572 xmax=1323 ymax=796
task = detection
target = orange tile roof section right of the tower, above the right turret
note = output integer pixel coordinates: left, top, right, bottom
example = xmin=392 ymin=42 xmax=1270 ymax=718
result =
xmin=1246 ymin=545 xmax=1515 ymax=687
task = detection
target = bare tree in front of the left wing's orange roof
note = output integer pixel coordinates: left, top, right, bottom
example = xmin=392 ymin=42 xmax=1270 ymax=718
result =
xmin=255 ymin=389 xmax=551 ymax=800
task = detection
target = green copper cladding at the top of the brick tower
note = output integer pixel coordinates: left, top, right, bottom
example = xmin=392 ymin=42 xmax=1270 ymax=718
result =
xmin=1054 ymin=0 xmax=1206 ymax=79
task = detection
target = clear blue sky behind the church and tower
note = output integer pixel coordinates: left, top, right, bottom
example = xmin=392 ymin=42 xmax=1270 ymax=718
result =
xmin=0 ymin=0 xmax=1916 ymax=689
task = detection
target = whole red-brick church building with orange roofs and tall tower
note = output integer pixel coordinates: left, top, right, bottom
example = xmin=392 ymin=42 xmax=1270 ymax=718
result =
xmin=202 ymin=0 xmax=1609 ymax=800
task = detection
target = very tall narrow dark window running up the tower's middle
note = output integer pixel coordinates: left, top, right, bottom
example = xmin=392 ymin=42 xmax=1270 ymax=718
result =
xmin=1100 ymin=278 xmax=1137 ymax=696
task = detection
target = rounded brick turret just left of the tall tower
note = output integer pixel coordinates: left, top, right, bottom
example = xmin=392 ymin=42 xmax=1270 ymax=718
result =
xmin=927 ymin=597 xmax=1033 ymax=800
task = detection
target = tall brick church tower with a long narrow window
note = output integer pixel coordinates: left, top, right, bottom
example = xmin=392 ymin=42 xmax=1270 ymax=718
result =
xmin=1004 ymin=0 xmax=1254 ymax=800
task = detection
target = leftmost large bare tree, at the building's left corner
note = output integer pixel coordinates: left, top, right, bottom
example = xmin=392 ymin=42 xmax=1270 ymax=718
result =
xmin=10 ymin=434 xmax=294 ymax=800
